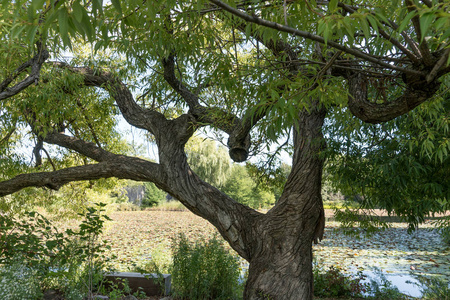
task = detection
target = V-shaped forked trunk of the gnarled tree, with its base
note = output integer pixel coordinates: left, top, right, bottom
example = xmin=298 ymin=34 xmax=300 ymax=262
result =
xmin=160 ymin=108 xmax=326 ymax=300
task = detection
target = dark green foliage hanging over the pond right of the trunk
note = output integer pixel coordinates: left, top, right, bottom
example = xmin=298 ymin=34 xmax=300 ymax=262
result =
xmin=328 ymin=92 xmax=450 ymax=229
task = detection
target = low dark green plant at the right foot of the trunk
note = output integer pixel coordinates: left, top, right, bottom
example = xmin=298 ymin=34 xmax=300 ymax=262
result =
xmin=313 ymin=264 xmax=367 ymax=297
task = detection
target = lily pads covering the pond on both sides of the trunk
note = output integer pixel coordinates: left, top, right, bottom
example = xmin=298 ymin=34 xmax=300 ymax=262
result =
xmin=104 ymin=211 xmax=450 ymax=279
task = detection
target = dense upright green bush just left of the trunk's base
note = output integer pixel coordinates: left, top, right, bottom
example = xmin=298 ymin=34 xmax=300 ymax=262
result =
xmin=171 ymin=235 xmax=242 ymax=300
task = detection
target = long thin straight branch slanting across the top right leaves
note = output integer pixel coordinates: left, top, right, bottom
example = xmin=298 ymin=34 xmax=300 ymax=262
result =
xmin=210 ymin=0 xmax=424 ymax=75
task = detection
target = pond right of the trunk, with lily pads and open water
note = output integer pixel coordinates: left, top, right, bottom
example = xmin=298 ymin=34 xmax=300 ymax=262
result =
xmin=313 ymin=222 xmax=450 ymax=297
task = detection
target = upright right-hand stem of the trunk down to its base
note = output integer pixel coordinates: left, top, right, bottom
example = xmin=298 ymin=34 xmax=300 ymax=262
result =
xmin=244 ymin=110 xmax=325 ymax=300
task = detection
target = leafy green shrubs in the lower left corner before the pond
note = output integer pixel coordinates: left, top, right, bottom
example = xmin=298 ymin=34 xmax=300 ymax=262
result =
xmin=0 ymin=204 xmax=112 ymax=299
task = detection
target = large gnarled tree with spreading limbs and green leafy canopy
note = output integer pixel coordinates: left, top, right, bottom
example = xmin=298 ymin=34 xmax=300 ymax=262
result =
xmin=0 ymin=0 xmax=450 ymax=299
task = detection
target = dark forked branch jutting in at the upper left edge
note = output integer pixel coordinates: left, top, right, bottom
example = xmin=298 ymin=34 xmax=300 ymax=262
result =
xmin=0 ymin=43 xmax=50 ymax=100
